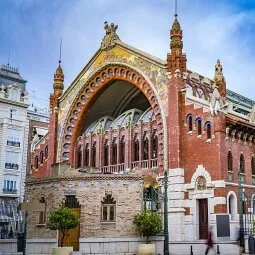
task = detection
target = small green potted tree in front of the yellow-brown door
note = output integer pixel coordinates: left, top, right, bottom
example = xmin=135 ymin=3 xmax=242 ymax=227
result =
xmin=48 ymin=205 xmax=80 ymax=247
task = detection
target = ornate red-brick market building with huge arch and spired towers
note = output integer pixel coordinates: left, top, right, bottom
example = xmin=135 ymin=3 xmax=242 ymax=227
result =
xmin=26 ymin=14 xmax=255 ymax=254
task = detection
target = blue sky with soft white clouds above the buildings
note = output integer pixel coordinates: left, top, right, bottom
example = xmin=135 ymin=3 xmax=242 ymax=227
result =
xmin=0 ymin=0 xmax=255 ymax=108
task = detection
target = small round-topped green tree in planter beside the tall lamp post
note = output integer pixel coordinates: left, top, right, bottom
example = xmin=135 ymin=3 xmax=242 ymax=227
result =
xmin=133 ymin=210 xmax=162 ymax=243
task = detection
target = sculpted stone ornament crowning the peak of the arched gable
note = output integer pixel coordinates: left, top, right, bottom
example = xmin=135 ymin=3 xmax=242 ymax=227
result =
xmin=101 ymin=21 xmax=120 ymax=50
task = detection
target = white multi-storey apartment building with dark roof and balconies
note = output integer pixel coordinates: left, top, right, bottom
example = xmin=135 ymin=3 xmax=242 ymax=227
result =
xmin=0 ymin=65 xmax=29 ymax=235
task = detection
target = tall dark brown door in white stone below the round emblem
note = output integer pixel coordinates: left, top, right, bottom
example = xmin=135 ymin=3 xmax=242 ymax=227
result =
xmin=198 ymin=199 xmax=208 ymax=239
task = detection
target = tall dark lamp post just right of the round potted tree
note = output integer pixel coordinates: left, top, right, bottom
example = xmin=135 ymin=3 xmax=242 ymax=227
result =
xmin=164 ymin=170 xmax=169 ymax=255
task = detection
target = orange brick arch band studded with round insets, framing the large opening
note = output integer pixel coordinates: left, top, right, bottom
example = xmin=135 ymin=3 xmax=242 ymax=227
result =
xmin=59 ymin=63 xmax=167 ymax=170
